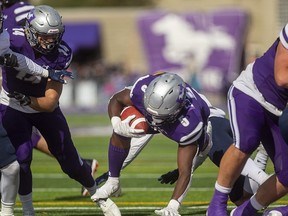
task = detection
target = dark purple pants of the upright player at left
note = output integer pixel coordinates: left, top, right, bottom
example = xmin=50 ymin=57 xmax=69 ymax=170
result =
xmin=0 ymin=105 xmax=95 ymax=195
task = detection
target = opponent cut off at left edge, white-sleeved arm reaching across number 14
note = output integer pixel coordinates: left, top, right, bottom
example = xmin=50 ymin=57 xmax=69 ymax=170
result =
xmin=0 ymin=3 xmax=72 ymax=216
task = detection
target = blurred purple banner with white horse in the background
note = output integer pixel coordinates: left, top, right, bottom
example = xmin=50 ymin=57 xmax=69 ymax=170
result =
xmin=138 ymin=7 xmax=249 ymax=106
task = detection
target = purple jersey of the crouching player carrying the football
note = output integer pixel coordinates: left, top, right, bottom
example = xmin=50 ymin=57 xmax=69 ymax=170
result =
xmin=131 ymin=75 xmax=210 ymax=149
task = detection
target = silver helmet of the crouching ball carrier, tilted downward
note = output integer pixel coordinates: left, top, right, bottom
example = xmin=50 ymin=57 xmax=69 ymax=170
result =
xmin=144 ymin=73 xmax=186 ymax=126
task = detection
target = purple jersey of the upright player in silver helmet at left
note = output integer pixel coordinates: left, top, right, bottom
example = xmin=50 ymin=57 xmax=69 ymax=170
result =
xmin=2 ymin=28 xmax=72 ymax=97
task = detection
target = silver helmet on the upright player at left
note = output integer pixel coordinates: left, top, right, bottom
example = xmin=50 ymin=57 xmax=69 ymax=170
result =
xmin=24 ymin=5 xmax=65 ymax=54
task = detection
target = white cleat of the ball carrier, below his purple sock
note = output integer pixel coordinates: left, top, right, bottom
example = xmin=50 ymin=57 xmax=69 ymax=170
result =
xmin=91 ymin=177 xmax=121 ymax=202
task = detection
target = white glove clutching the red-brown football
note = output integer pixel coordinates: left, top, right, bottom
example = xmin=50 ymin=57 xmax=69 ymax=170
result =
xmin=111 ymin=115 xmax=145 ymax=137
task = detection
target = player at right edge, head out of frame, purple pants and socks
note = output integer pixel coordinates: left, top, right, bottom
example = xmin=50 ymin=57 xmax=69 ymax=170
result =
xmin=207 ymin=19 xmax=288 ymax=216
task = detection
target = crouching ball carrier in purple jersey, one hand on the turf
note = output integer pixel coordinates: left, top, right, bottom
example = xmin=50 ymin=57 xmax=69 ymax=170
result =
xmin=92 ymin=73 xmax=267 ymax=216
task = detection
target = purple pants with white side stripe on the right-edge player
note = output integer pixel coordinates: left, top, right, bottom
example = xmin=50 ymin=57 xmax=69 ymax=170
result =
xmin=228 ymin=87 xmax=288 ymax=187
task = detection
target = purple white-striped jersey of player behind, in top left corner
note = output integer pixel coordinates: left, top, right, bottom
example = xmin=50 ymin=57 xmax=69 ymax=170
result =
xmin=3 ymin=2 xmax=34 ymax=29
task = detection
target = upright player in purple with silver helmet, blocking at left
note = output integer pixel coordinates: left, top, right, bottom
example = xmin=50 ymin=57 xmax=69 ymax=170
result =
xmin=0 ymin=5 xmax=120 ymax=216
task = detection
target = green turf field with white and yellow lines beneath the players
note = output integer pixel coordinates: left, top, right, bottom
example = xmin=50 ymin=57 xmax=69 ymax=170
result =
xmin=15 ymin=116 xmax=288 ymax=216
